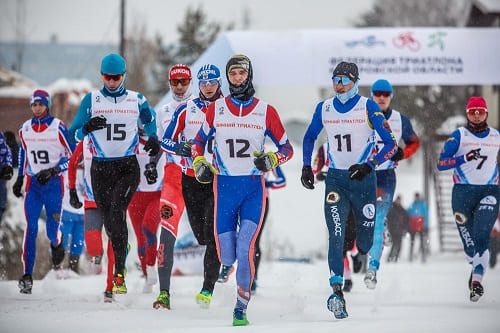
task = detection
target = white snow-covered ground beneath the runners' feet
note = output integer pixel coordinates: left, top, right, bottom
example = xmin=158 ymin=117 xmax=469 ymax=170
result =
xmin=0 ymin=253 xmax=500 ymax=333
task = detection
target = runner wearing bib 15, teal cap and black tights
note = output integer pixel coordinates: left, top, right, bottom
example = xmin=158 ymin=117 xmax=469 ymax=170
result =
xmin=70 ymin=53 xmax=160 ymax=293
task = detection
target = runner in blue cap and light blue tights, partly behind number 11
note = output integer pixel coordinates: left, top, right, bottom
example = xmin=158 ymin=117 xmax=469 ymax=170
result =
xmin=364 ymin=79 xmax=420 ymax=289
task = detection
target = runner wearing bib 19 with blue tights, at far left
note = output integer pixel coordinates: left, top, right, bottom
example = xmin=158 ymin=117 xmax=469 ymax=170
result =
xmin=13 ymin=89 xmax=73 ymax=294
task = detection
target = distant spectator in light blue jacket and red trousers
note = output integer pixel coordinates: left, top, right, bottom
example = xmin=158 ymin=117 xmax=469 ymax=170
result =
xmin=408 ymin=192 xmax=429 ymax=262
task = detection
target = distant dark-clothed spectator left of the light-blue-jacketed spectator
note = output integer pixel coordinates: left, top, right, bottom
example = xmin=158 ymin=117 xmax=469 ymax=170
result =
xmin=387 ymin=195 xmax=410 ymax=262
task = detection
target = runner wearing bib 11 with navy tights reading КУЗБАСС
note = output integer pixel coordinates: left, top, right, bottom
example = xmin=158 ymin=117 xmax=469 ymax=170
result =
xmin=301 ymin=62 xmax=397 ymax=319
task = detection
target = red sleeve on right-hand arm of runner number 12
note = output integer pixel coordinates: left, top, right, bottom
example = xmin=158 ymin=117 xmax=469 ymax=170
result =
xmin=266 ymin=105 xmax=293 ymax=165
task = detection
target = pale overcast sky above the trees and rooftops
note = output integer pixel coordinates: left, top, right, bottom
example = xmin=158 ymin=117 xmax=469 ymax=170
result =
xmin=0 ymin=0 xmax=375 ymax=44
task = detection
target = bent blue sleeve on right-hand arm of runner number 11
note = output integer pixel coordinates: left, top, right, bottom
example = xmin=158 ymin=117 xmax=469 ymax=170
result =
xmin=366 ymin=99 xmax=398 ymax=168
